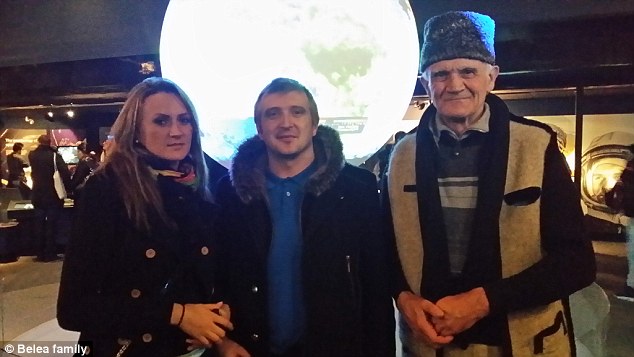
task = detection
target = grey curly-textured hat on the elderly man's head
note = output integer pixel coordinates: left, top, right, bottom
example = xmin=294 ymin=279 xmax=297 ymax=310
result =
xmin=420 ymin=11 xmax=495 ymax=73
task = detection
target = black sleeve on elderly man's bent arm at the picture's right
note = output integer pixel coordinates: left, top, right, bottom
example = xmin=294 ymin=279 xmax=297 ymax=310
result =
xmin=484 ymin=137 xmax=596 ymax=313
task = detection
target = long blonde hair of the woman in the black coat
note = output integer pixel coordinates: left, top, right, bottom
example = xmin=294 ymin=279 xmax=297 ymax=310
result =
xmin=100 ymin=77 xmax=211 ymax=232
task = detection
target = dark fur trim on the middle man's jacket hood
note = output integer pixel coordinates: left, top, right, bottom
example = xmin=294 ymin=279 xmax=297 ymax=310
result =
xmin=229 ymin=125 xmax=346 ymax=203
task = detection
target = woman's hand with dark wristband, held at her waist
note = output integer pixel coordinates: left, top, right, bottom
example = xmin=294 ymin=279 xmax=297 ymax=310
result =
xmin=170 ymin=302 xmax=233 ymax=348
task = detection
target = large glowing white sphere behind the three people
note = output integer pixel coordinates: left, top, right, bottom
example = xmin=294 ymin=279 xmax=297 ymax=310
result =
xmin=160 ymin=0 xmax=419 ymax=166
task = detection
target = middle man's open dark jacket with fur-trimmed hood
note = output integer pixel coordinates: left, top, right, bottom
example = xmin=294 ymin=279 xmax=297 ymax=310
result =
xmin=218 ymin=126 xmax=394 ymax=356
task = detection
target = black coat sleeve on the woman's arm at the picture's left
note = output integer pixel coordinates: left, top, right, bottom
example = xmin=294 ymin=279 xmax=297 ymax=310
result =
xmin=57 ymin=177 xmax=122 ymax=334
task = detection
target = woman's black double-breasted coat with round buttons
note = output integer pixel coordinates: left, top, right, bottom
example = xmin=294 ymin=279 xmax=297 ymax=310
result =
xmin=57 ymin=171 xmax=217 ymax=356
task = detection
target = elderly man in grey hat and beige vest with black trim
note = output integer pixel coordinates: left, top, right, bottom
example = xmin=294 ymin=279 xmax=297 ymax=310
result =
xmin=383 ymin=12 xmax=595 ymax=357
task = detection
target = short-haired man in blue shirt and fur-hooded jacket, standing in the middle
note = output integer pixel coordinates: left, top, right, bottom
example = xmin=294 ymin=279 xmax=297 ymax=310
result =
xmin=218 ymin=78 xmax=395 ymax=357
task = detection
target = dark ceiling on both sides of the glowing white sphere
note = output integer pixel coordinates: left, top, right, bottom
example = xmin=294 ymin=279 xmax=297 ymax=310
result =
xmin=0 ymin=0 xmax=634 ymax=117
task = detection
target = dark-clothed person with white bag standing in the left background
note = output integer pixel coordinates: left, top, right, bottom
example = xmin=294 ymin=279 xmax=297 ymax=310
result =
xmin=29 ymin=135 xmax=70 ymax=262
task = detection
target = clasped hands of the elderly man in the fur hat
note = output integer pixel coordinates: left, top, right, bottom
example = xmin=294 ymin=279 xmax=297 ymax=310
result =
xmin=397 ymin=288 xmax=489 ymax=348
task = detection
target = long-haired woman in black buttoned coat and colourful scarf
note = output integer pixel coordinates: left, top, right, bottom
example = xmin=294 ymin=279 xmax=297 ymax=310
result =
xmin=57 ymin=78 xmax=232 ymax=356
